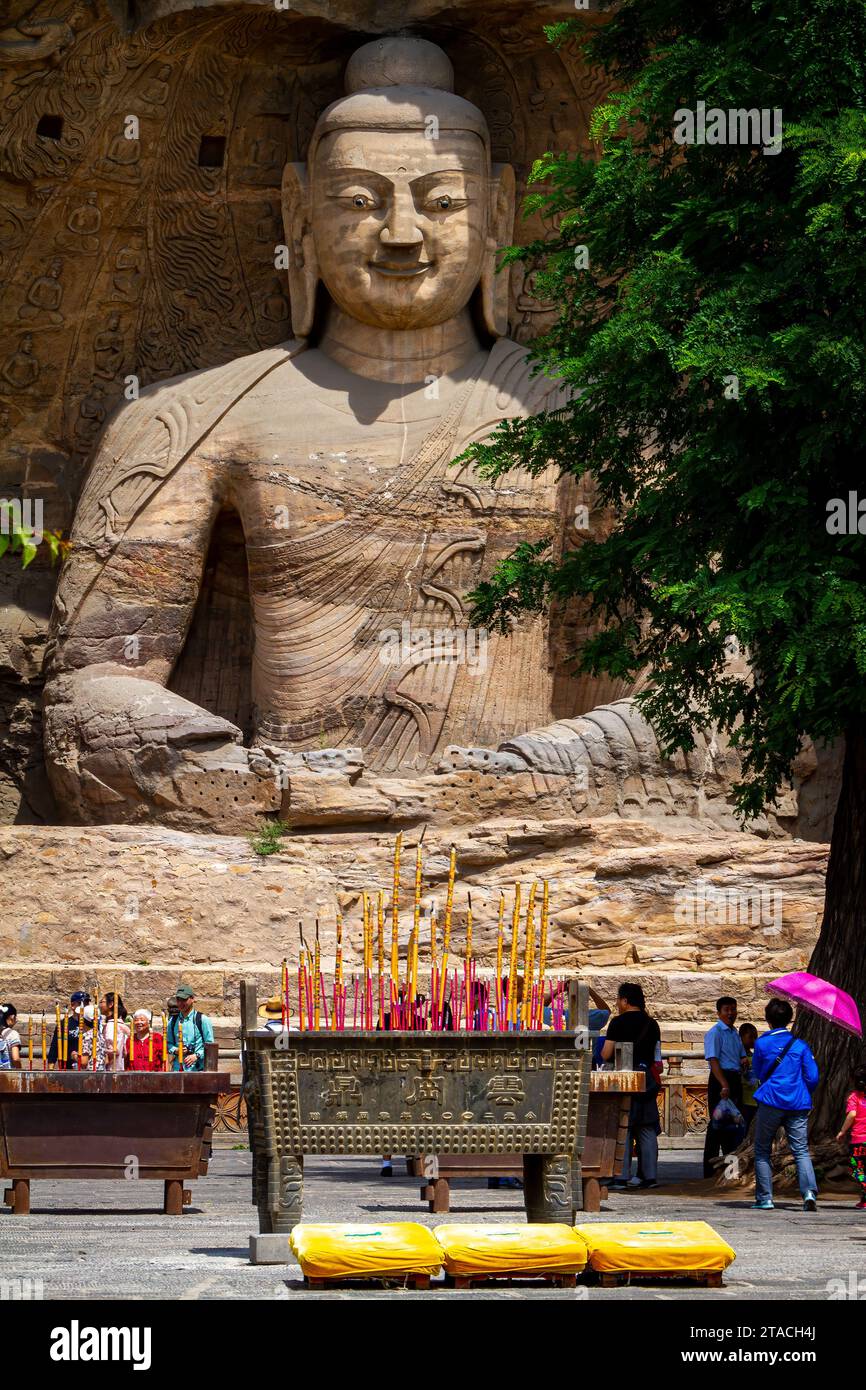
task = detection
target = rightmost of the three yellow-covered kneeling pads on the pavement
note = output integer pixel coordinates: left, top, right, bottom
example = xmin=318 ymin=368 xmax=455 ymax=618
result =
xmin=574 ymin=1220 xmax=737 ymax=1273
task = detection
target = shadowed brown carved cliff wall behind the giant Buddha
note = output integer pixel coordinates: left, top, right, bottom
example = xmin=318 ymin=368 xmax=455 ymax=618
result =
xmin=0 ymin=0 xmax=623 ymax=821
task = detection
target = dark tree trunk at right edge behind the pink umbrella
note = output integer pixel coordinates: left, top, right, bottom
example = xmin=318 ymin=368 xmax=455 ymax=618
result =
xmin=794 ymin=720 xmax=866 ymax=1145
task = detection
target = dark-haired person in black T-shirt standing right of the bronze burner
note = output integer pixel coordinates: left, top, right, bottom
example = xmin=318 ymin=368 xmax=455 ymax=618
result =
xmin=602 ymin=981 xmax=662 ymax=1187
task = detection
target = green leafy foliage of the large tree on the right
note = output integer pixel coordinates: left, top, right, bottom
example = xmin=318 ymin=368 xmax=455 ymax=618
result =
xmin=473 ymin=0 xmax=866 ymax=816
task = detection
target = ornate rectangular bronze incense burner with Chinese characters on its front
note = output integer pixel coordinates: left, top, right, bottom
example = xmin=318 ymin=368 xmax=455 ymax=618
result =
xmin=242 ymin=983 xmax=589 ymax=1233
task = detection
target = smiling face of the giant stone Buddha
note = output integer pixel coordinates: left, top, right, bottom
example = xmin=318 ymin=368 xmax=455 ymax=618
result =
xmin=311 ymin=131 xmax=489 ymax=329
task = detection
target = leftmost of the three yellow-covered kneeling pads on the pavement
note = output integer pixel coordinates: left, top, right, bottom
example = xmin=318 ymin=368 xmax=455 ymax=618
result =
xmin=289 ymin=1220 xmax=442 ymax=1279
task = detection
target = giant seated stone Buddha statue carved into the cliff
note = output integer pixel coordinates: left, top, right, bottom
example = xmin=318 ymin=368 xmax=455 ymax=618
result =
xmin=40 ymin=38 xmax=733 ymax=830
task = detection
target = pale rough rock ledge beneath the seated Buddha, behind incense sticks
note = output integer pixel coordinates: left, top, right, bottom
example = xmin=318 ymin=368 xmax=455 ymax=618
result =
xmin=0 ymin=817 xmax=826 ymax=1026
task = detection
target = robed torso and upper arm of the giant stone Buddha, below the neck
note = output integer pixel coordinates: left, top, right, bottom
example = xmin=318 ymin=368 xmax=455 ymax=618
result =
xmin=50 ymin=339 xmax=589 ymax=773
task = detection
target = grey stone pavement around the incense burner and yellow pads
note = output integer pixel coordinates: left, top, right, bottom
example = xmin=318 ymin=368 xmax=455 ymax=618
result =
xmin=0 ymin=1148 xmax=866 ymax=1302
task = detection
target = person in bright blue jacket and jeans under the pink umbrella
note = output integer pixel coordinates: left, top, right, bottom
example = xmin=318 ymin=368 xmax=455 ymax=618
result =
xmin=752 ymin=999 xmax=819 ymax=1212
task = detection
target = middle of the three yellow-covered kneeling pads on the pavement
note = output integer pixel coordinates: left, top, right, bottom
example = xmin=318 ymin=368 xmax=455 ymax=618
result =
xmin=434 ymin=1223 xmax=587 ymax=1275
